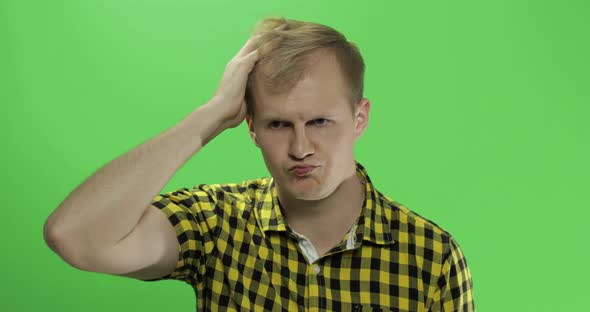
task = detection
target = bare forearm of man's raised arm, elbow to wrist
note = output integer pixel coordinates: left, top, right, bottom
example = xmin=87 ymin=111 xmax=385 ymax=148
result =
xmin=45 ymin=102 xmax=228 ymax=255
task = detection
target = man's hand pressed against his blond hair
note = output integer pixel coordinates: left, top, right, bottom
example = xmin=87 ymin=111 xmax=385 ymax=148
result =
xmin=208 ymin=24 xmax=286 ymax=129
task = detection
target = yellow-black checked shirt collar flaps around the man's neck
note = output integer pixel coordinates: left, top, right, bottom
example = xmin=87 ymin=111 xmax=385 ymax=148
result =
xmin=255 ymin=160 xmax=394 ymax=244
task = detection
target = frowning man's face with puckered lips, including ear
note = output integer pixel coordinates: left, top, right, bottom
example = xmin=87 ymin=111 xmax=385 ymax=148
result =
xmin=246 ymin=50 xmax=370 ymax=200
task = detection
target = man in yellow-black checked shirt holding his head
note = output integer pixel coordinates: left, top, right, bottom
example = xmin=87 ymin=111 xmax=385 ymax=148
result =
xmin=44 ymin=18 xmax=475 ymax=311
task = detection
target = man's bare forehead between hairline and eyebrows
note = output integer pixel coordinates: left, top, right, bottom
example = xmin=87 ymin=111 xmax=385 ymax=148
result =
xmin=254 ymin=50 xmax=350 ymax=119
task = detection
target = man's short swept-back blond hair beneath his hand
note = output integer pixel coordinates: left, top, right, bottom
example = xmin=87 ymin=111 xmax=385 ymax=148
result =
xmin=245 ymin=17 xmax=365 ymax=118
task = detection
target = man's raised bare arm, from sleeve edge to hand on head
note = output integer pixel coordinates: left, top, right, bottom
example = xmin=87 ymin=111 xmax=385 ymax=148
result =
xmin=43 ymin=28 xmax=282 ymax=276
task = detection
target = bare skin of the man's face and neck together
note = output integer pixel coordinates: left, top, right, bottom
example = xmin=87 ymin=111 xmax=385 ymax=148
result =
xmin=246 ymin=50 xmax=370 ymax=255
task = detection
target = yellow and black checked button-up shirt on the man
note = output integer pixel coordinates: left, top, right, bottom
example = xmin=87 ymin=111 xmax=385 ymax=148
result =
xmin=145 ymin=162 xmax=475 ymax=311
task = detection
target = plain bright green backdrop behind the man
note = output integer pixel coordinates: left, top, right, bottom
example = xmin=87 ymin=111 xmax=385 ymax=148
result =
xmin=0 ymin=0 xmax=590 ymax=311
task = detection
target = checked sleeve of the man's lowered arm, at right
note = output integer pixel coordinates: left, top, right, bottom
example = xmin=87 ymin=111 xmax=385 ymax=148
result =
xmin=430 ymin=237 xmax=475 ymax=312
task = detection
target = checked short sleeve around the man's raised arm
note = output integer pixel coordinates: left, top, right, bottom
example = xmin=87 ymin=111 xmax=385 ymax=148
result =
xmin=143 ymin=185 xmax=216 ymax=285
